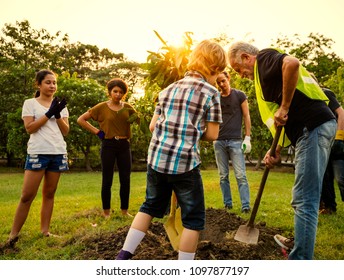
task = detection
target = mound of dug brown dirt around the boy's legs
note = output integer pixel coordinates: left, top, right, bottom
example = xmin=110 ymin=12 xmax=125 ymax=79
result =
xmin=79 ymin=208 xmax=284 ymax=260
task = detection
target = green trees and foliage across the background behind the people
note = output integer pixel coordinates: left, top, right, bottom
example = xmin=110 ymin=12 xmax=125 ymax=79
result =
xmin=0 ymin=20 xmax=344 ymax=170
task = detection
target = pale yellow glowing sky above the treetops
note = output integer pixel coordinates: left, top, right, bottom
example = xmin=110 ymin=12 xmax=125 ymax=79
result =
xmin=0 ymin=0 xmax=344 ymax=62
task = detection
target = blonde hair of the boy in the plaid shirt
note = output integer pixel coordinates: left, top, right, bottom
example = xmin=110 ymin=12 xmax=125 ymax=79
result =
xmin=187 ymin=40 xmax=227 ymax=76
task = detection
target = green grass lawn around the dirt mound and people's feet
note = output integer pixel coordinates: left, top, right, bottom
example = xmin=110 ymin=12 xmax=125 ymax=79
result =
xmin=0 ymin=166 xmax=344 ymax=260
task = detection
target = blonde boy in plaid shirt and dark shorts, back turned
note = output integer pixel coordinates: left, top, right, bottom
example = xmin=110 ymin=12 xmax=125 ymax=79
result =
xmin=116 ymin=40 xmax=227 ymax=260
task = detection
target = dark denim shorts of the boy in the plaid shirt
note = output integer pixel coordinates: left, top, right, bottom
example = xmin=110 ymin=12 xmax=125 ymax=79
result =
xmin=140 ymin=165 xmax=205 ymax=230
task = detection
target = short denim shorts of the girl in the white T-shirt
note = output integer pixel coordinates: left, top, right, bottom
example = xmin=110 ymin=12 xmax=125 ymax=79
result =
xmin=24 ymin=154 xmax=69 ymax=172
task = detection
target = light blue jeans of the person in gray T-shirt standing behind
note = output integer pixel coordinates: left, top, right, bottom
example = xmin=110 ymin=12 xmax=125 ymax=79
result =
xmin=213 ymin=140 xmax=250 ymax=210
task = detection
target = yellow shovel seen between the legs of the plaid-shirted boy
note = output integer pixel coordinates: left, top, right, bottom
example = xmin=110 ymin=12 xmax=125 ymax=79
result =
xmin=164 ymin=192 xmax=184 ymax=251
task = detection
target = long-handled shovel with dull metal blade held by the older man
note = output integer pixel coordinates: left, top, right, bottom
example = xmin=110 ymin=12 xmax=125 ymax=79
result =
xmin=234 ymin=126 xmax=282 ymax=244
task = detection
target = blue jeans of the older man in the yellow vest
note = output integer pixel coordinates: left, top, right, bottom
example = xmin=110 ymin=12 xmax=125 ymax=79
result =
xmin=289 ymin=120 xmax=337 ymax=260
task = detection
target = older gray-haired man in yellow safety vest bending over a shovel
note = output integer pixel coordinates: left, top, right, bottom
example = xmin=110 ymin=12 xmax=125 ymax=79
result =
xmin=228 ymin=42 xmax=336 ymax=260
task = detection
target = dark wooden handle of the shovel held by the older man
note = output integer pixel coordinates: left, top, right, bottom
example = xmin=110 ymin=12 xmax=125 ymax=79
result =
xmin=247 ymin=126 xmax=282 ymax=227
